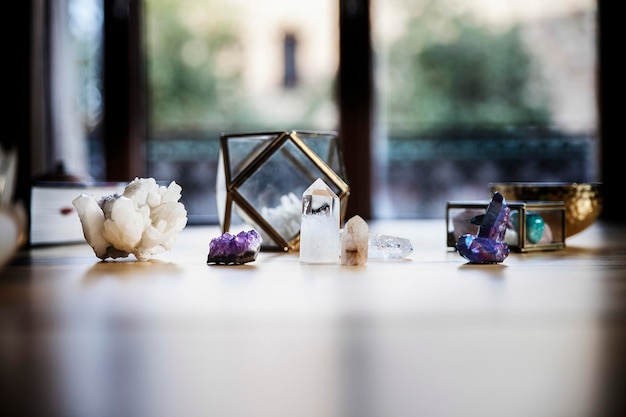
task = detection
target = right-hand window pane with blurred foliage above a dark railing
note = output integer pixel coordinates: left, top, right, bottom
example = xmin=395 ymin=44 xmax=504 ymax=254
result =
xmin=372 ymin=0 xmax=599 ymax=218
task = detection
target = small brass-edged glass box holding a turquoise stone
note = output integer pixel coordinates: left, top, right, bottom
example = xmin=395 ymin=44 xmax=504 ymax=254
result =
xmin=446 ymin=201 xmax=565 ymax=252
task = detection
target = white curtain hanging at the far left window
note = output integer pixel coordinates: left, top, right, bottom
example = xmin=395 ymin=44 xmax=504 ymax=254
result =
xmin=31 ymin=0 xmax=88 ymax=177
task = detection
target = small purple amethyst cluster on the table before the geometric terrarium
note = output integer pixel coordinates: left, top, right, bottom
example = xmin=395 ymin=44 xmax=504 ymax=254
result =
xmin=207 ymin=229 xmax=263 ymax=265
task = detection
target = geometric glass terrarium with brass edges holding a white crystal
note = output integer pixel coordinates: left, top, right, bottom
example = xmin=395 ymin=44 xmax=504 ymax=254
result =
xmin=216 ymin=131 xmax=350 ymax=251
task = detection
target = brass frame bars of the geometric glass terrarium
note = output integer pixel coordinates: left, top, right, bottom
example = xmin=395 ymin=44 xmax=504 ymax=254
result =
xmin=217 ymin=131 xmax=350 ymax=251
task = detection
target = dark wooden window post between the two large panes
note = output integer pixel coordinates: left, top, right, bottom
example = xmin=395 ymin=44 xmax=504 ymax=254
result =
xmin=338 ymin=0 xmax=373 ymax=219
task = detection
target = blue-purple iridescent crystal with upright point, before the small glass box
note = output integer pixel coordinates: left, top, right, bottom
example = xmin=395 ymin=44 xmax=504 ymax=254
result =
xmin=456 ymin=191 xmax=511 ymax=264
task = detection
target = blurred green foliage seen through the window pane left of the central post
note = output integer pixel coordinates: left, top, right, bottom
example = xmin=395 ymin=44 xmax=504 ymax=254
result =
xmin=146 ymin=0 xmax=254 ymax=131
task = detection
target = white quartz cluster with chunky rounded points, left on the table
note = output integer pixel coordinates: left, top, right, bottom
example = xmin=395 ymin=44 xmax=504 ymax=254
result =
xmin=72 ymin=178 xmax=187 ymax=261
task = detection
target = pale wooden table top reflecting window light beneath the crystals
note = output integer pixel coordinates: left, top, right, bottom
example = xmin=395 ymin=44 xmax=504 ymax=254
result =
xmin=0 ymin=220 xmax=626 ymax=417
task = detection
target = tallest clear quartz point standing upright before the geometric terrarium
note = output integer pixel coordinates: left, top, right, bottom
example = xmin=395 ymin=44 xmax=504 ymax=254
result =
xmin=300 ymin=178 xmax=341 ymax=263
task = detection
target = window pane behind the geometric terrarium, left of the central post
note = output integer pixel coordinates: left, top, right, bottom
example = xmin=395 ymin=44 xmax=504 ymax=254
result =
xmin=145 ymin=0 xmax=338 ymax=222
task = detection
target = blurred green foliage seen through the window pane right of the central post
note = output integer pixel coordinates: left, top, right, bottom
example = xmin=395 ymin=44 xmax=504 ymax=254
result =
xmin=385 ymin=0 xmax=550 ymax=135
